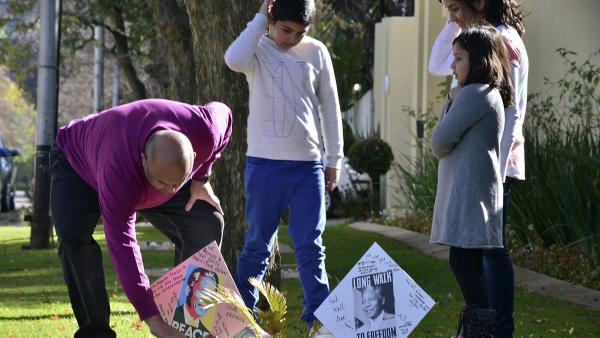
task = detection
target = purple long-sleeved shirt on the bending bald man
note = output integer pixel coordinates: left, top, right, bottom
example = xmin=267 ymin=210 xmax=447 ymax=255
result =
xmin=56 ymin=99 xmax=232 ymax=320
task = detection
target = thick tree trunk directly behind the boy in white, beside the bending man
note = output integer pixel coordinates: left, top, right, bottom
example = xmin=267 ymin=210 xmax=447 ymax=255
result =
xmin=184 ymin=0 xmax=261 ymax=272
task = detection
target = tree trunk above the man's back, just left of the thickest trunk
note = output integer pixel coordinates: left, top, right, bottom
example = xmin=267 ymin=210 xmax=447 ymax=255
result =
xmin=146 ymin=0 xmax=196 ymax=103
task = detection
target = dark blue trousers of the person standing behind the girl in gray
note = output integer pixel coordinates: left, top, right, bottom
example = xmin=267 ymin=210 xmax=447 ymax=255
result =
xmin=483 ymin=177 xmax=515 ymax=338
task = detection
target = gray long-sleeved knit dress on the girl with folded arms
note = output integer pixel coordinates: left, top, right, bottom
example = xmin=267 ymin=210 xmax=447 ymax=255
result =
xmin=431 ymin=84 xmax=504 ymax=248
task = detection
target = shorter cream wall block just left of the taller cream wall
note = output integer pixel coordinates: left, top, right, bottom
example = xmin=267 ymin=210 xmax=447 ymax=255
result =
xmin=373 ymin=17 xmax=422 ymax=207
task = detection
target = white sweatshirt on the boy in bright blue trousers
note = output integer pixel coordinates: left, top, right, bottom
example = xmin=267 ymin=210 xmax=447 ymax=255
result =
xmin=225 ymin=13 xmax=343 ymax=169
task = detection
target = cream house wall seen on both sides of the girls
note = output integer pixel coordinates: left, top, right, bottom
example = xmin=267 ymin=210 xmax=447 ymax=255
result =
xmin=373 ymin=0 xmax=600 ymax=208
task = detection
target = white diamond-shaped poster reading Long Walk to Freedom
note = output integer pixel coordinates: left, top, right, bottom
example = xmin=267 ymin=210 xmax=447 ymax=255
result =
xmin=315 ymin=243 xmax=435 ymax=338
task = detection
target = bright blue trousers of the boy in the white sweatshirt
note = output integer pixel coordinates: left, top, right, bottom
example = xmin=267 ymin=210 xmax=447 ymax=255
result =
xmin=235 ymin=157 xmax=329 ymax=325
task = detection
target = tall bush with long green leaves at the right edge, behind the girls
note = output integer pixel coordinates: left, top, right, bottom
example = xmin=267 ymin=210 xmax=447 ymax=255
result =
xmin=510 ymin=49 xmax=600 ymax=266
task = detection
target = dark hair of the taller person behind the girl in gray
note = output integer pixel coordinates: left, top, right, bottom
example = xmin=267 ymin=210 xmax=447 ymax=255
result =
xmin=438 ymin=0 xmax=525 ymax=36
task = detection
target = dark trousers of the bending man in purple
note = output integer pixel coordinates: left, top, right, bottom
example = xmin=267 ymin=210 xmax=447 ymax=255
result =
xmin=50 ymin=146 xmax=224 ymax=338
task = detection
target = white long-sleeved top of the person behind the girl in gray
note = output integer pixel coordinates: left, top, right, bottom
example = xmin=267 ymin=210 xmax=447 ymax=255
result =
xmin=429 ymin=21 xmax=529 ymax=180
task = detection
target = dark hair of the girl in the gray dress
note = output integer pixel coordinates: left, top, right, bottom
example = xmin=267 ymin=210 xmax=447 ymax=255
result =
xmin=452 ymin=26 xmax=513 ymax=107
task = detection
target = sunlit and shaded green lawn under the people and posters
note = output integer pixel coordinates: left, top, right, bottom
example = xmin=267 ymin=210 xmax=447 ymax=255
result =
xmin=0 ymin=226 xmax=600 ymax=338
